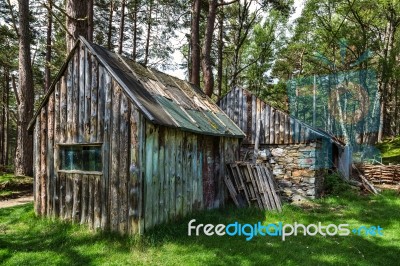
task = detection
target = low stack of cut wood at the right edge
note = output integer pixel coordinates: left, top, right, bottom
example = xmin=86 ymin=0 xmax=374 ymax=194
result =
xmin=357 ymin=164 xmax=400 ymax=185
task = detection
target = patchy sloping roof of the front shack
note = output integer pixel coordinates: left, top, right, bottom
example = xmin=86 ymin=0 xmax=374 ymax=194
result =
xmin=28 ymin=37 xmax=245 ymax=138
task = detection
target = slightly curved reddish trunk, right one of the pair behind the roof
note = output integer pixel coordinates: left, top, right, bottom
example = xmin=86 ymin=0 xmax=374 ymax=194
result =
xmin=201 ymin=0 xmax=218 ymax=97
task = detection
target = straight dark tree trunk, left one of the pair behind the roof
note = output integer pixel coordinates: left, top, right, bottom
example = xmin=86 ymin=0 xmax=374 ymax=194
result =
xmin=190 ymin=0 xmax=200 ymax=86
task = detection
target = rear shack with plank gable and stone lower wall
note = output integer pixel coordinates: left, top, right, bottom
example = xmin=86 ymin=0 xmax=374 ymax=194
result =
xmin=218 ymin=88 xmax=351 ymax=199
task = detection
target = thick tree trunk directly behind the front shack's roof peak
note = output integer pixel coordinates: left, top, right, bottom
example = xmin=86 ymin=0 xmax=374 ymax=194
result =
xmin=66 ymin=0 xmax=88 ymax=52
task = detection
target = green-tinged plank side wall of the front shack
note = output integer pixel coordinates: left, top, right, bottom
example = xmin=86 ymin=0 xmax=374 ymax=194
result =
xmin=143 ymin=122 xmax=239 ymax=230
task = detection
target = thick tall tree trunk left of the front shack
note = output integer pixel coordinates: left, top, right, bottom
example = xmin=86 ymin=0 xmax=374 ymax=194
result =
xmin=15 ymin=0 xmax=34 ymax=176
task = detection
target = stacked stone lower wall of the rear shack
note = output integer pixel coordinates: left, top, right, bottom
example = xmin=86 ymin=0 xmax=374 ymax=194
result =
xmin=241 ymin=141 xmax=329 ymax=202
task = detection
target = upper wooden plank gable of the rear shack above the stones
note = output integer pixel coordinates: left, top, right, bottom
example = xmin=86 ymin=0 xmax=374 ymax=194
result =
xmin=218 ymin=88 xmax=324 ymax=145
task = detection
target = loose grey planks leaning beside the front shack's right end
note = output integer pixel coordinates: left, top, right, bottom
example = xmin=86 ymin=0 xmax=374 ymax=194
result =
xmin=225 ymin=162 xmax=282 ymax=211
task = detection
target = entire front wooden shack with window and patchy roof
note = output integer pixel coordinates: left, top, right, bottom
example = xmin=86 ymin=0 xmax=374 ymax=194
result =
xmin=29 ymin=37 xmax=244 ymax=234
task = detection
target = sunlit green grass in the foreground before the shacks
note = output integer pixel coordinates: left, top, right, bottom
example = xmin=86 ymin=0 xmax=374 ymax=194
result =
xmin=0 ymin=190 xmax=400 ymax=265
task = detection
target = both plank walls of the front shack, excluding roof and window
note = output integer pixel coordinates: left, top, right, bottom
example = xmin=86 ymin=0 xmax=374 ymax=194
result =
xmin=34 ymin=41 xmax=239 ymax=234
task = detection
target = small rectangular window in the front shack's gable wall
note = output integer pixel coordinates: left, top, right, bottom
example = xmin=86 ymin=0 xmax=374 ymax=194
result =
xmin=60 ymin=144 xmax=102 ymax=172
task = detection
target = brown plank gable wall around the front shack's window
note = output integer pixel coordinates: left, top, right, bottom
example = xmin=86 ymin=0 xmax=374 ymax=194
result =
xmin=34 ymin=45 xmax=140 ymax=233
